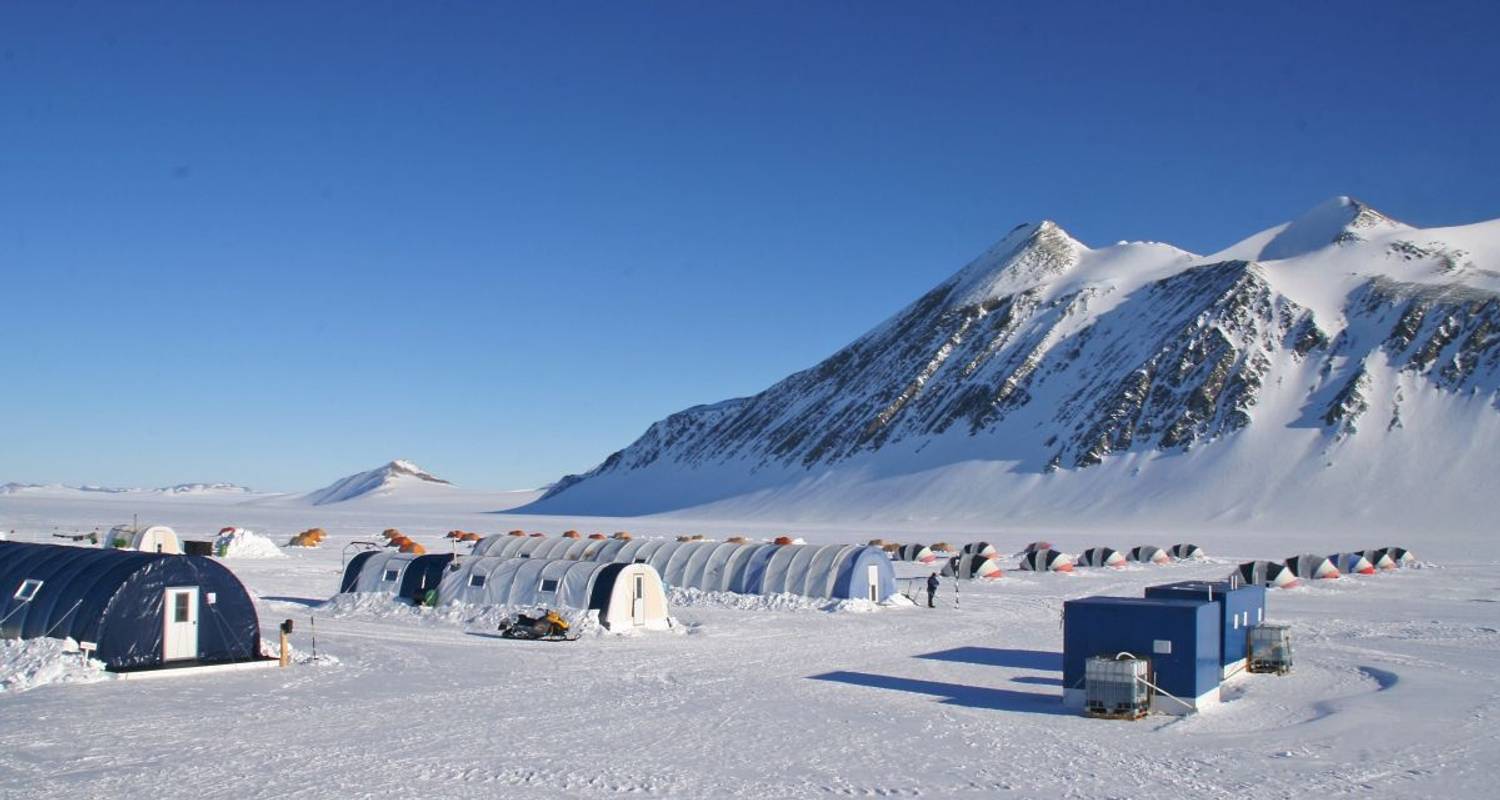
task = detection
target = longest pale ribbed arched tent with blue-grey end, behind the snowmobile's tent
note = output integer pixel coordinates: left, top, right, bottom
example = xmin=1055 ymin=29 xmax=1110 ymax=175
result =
xmin=474 ymin=536 xmax=896 ymax=602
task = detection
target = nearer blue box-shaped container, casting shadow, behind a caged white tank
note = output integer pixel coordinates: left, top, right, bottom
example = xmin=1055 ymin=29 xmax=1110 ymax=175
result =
xmin=1062 ymin=597 xmax=1220 ymax=714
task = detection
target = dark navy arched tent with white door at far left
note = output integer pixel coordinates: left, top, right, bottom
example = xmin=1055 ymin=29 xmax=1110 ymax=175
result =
xmin=0 ymin=542 xmax=261 ymax=671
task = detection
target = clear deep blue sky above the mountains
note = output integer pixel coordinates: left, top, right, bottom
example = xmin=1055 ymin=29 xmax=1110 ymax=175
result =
xmin=0 ymin=0 xmax=1500 ymax=489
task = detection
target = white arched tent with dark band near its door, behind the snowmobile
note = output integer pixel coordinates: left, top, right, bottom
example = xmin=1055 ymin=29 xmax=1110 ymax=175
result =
xmin=438 ymin=555 xmax=669 ymax=630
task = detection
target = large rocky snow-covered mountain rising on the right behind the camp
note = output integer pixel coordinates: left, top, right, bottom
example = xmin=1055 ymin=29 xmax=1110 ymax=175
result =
xmin=522 ymin=197 xmax=1500 ymax=525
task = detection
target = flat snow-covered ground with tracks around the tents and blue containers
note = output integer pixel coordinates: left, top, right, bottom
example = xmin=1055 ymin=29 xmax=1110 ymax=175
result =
xmin=0 ymin=495 xmax=1500 ymax=798
